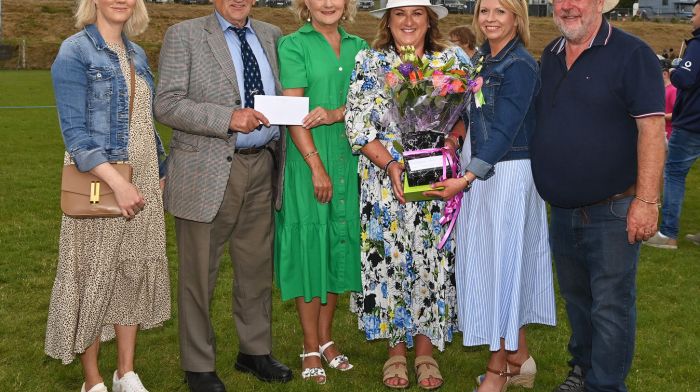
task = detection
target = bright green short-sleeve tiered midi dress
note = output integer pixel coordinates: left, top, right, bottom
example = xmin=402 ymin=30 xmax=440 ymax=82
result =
xmin=275 ymin=23 xmax=367 ymax=303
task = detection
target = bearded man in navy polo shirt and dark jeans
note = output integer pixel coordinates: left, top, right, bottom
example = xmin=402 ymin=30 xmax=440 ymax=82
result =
xmin=530 ymin=0 xmax=665 ymax=392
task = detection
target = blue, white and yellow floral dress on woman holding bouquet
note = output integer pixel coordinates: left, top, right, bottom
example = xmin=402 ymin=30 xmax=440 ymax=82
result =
xmin=345 ymin=48 xmax=468 ymax=350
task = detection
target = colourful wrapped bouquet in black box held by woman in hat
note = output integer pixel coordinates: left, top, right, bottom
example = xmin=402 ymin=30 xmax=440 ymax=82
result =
xmin=385 ymin=46 xmax=483 ymax=201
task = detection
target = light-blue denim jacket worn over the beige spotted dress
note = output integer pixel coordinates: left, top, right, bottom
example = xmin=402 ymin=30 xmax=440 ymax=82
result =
xmin=51 ymin=25 xmax=165 ymax=176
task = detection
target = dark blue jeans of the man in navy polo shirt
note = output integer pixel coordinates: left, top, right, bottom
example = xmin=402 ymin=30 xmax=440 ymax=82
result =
xmin=549 ymin=197 xmax=639 ymax=392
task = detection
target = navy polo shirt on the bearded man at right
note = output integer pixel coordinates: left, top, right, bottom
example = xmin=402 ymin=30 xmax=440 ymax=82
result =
xmin=530 ymin=18 xmax=664 ymax=208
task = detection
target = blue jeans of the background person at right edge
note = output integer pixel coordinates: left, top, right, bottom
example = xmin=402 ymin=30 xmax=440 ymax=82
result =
xmin=659 ymin=128 xmax=700 ymax=239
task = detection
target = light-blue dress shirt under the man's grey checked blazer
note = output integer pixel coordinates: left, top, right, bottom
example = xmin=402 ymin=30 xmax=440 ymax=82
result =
xmin=215 ymin=12 xmax=280 ymax=148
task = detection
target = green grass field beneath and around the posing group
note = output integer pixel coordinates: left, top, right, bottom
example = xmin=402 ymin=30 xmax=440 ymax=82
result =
xmin=0 ymin=71 xmax=700 ymax=392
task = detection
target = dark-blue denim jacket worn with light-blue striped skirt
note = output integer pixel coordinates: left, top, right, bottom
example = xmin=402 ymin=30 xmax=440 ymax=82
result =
xmin=465 ymin=37 xmax=540 ymax=180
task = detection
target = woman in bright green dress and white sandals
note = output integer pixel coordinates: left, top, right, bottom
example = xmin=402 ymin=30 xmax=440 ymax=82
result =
xmin=275 ymin=0 xmax=367 ymax=384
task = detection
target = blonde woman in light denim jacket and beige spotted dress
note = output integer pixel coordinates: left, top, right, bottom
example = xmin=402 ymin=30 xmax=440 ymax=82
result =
xmin=45 ymin=0 xmax=170 ymax=392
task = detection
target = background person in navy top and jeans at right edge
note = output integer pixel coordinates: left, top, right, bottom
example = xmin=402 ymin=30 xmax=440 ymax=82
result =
xmin=645 ymin=0 xmax=700 ymax=249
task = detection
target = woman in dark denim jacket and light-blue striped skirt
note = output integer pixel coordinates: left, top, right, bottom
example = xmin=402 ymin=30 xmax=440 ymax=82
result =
xmin=424 ymin=0 xmax=555 ymax=391
